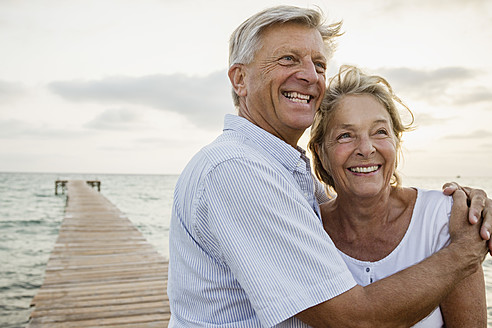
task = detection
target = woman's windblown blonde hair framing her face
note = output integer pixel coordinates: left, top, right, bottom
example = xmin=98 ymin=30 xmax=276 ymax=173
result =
xmin=308 ymin=65 xmax=414 ymax=188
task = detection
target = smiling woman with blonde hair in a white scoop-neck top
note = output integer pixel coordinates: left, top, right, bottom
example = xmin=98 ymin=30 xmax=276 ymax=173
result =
xmin=308 ymin=66 xmax=487 ymax=328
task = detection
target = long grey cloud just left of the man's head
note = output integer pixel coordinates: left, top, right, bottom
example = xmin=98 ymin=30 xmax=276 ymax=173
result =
xmin=49 ymin=71 xmax=234 ymax=128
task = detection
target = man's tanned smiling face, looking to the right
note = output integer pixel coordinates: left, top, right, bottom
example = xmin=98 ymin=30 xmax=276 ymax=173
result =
xmin=239 ymin=23 xmax=326 ymax=146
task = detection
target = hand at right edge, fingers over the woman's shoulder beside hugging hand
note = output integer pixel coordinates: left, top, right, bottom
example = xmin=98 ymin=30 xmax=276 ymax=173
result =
xmin=443 ymin=182 xmax=492 ymax=254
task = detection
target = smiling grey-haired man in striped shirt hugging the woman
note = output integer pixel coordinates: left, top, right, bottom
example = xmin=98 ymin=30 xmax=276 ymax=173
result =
xmin=168 ymin=6 xmax=490 ymax=327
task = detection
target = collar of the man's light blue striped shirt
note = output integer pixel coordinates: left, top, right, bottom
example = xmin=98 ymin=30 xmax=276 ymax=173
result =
xmin=224 ymin=114 xmax=310 ymax=172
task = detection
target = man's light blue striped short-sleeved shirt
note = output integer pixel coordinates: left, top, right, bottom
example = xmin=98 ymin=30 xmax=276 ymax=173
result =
xmin=168 ymin=115 xmax=355 ymax=327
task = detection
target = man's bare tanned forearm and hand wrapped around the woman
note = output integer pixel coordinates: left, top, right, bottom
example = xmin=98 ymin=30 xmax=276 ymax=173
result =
xmin=297 ymin=191 xmax=487 ymax=327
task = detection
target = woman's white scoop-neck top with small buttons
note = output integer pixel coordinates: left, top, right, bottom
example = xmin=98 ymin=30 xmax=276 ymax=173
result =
xmin=339 ymin=188 xmax=453 ymax=328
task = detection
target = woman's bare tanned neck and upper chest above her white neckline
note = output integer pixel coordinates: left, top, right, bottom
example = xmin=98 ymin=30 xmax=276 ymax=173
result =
xmin=321 ymin=187 xmax=416 ymax=261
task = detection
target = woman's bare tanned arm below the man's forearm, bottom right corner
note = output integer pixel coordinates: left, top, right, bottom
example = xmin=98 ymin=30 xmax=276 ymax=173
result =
xmin=441 ymin=267 xmax=487 ymax=328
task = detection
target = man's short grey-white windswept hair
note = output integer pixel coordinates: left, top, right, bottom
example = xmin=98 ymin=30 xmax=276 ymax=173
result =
xmin=229 ymin=6 xmax=342 ymax=107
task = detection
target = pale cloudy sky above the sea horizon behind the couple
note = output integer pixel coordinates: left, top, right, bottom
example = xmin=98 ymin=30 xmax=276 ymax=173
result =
xmin=0 ymin=0 xmax=492 ymax=177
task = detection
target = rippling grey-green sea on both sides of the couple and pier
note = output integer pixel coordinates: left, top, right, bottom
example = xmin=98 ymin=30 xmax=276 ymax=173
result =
xmin=0 ymin=172 xmax=492 ymax=328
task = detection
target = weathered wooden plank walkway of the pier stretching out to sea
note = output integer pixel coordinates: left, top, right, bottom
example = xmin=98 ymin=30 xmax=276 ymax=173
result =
xmin=27 ymin=181 xmax=170 ymax=328
